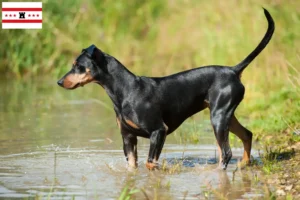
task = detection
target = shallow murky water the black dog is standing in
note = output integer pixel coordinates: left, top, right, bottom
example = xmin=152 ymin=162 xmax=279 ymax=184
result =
xmin=0 ymin=80 xmax=264 ymax=199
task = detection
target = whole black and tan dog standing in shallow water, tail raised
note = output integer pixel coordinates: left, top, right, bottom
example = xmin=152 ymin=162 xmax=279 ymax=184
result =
xmin=58 ymin=9 xmax=275 ymax=170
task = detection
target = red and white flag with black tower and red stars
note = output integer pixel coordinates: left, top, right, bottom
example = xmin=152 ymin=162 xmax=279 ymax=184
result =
xmin=2 ymin=2 xmax=42 ymax=29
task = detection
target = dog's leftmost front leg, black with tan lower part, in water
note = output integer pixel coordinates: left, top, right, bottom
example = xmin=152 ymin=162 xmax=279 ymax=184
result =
xmin=122 ymin=132 xmax=137 ymax=168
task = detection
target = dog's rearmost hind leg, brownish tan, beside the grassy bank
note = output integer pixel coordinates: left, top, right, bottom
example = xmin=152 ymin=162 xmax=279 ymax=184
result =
xmin=229 ymin=115 xmax=252 ymax=167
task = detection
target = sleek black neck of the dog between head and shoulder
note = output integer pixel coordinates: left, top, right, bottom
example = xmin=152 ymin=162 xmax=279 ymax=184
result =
xmin=97 ymin=55 xmax=136 ymax=108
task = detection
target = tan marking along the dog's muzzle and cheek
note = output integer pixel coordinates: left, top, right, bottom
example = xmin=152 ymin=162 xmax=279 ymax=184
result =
xmin=63 ymin=69 xmax=94 ymax=89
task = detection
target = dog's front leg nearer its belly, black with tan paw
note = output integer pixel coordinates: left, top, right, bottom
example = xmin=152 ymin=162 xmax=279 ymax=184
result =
xmin=146 ymin=127 xmax=167 ymax=170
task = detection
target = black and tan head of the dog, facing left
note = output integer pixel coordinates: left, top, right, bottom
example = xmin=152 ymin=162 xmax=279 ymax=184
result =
xmin=57 ymin=45 xmax=107 ymax=89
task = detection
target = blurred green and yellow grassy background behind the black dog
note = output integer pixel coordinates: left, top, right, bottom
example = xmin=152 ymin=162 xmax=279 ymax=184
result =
xmin=0 ymin=0 xmax=300 ymax=141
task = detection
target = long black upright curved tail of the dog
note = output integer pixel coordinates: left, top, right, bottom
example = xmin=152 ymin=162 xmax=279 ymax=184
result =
xmin=233 ymin=8 xmax=275 ymax=75
